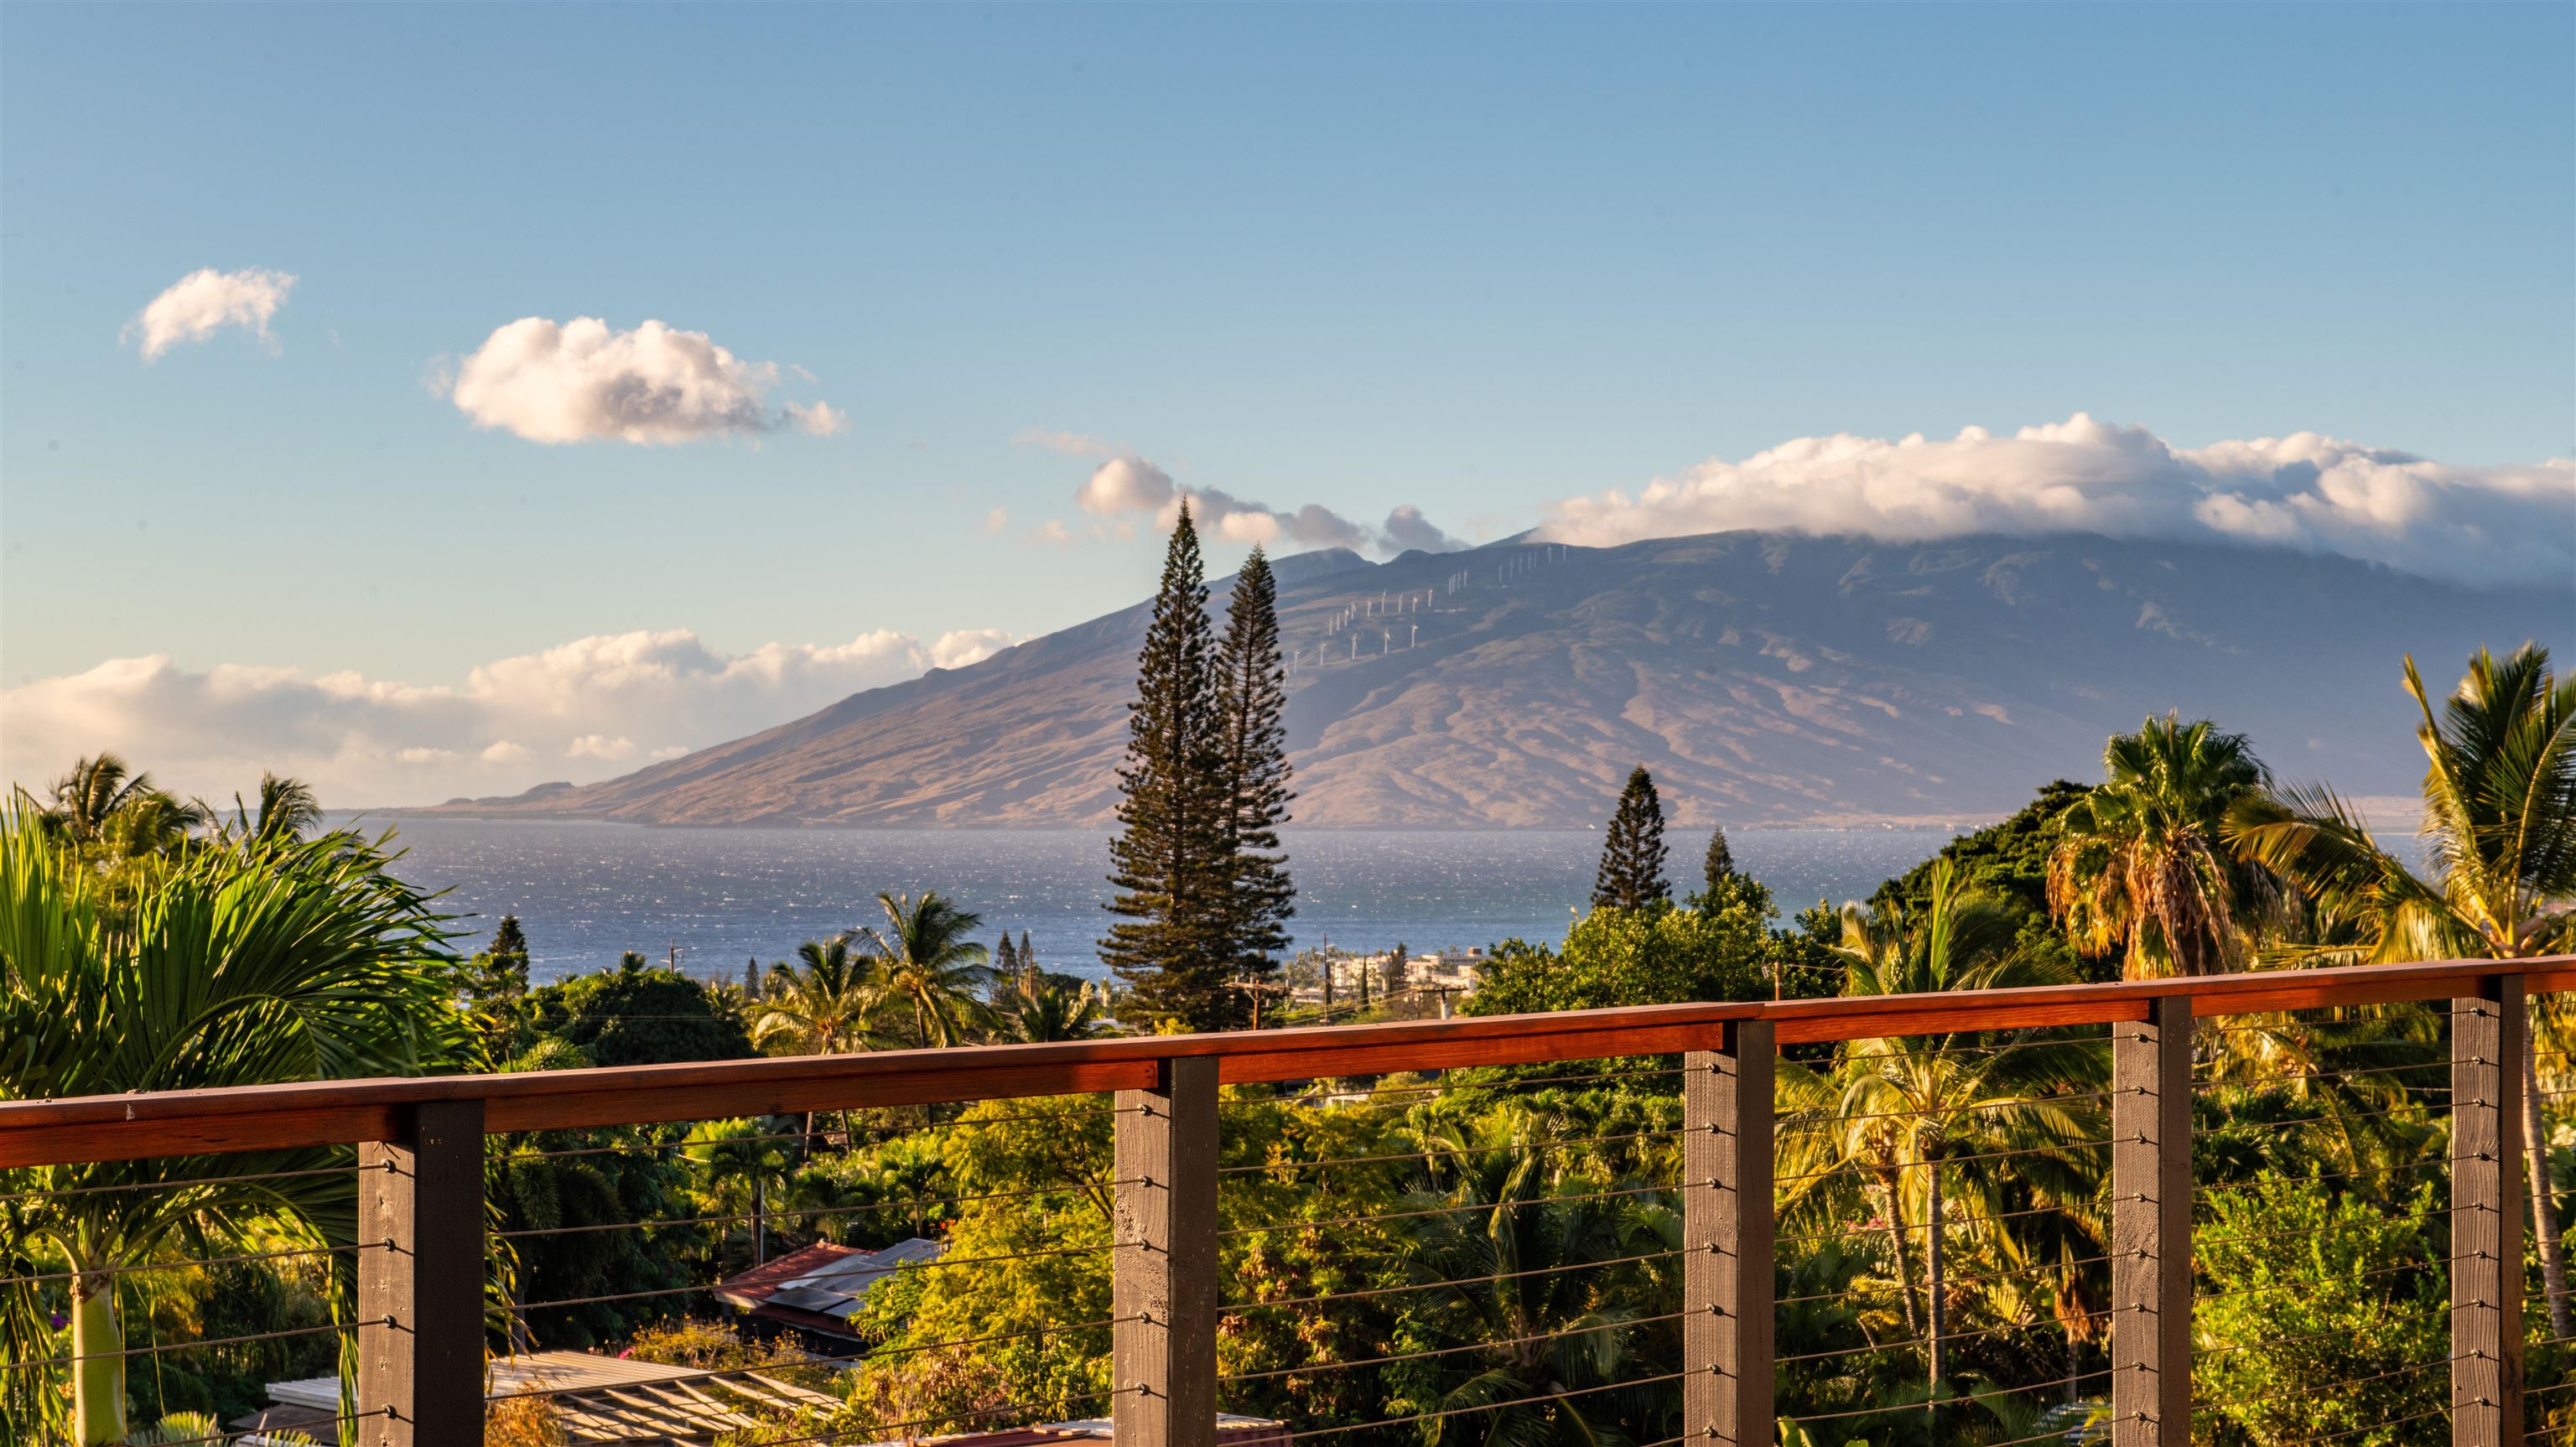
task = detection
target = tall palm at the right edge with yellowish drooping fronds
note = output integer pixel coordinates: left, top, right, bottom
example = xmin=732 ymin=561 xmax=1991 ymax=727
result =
xmin=2228 ymin=644 xmax=2576 ymax=1336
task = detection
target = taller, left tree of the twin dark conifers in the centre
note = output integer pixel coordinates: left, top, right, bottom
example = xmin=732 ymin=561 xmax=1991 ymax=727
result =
xmin=1100 ymin=500 xmax=1237 ymax=1029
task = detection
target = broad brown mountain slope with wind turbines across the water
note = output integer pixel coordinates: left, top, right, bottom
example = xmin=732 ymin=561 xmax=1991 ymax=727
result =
xmin=427 ymin=533 xmax=2576 ymax=829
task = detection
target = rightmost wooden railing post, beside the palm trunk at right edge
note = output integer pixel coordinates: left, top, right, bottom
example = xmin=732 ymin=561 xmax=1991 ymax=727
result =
xmin=2449 ymin=976 xmax=2530 ymax=1447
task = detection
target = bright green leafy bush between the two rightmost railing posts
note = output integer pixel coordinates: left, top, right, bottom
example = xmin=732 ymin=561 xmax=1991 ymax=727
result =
xmin=2192 ymin=1177 xmax=2449 ymax=1447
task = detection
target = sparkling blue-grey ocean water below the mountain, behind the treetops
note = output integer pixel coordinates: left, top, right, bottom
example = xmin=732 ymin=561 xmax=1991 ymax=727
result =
xmin=342 ymin=819 xmax=1978 ymax=978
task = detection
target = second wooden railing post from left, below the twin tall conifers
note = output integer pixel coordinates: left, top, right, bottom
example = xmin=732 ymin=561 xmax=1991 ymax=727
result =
xmin=1110 ymin=1055 xmax=1216 ymax=1447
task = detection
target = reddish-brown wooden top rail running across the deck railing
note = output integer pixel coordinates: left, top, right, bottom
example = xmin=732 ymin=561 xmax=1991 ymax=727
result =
xmin=0 ymin=955 xmax=2576 ymax=1166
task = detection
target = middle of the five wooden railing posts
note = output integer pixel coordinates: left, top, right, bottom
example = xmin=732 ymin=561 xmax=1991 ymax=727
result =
xmin=1682 ymin=1019 xmax=1775 ymax=1447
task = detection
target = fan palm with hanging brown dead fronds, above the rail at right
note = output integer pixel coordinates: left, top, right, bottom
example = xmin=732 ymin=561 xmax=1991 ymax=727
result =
xmin=2048 ymin=713 xmax=2272 ymax=978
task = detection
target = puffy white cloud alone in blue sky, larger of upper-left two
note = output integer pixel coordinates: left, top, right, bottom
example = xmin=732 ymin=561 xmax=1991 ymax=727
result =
xmin=443 ymin=317 xmax=850 ymax=445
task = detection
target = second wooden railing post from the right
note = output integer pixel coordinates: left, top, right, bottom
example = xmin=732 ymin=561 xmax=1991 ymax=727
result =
xmin=2110 ymin=993 xmax=2192 ymax=1447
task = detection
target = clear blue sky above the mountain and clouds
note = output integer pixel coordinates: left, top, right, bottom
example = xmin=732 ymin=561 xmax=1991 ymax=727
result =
xmin=0 ymin=5 xmax=2576 ymax=777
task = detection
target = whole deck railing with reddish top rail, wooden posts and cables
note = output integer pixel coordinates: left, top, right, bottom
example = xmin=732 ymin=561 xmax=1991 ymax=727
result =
xmin=0 ymin=957 xmax=2576 ymax=1447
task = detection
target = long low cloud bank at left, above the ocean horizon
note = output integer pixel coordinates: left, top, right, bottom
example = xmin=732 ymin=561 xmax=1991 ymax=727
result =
xmin=0 ymin=618 xmax=1012 ymax=806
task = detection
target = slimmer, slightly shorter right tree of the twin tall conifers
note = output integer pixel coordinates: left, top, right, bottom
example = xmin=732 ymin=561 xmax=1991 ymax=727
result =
xmin=1216 ymin=548 xmax=1296 ymax=1014
